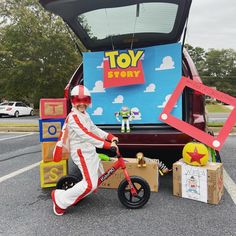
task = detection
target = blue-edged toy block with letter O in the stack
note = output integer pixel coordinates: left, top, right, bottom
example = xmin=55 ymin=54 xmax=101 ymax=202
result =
xmin=39 ymin=119 xmax=65 ymax=142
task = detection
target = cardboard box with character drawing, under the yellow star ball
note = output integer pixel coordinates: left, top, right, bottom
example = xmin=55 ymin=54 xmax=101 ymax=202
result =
xmin=173 ymin=159 xmax=224 ymax=204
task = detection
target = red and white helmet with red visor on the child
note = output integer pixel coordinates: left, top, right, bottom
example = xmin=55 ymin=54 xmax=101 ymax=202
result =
xmin=71 ymin=85 xmax=92 ymax=106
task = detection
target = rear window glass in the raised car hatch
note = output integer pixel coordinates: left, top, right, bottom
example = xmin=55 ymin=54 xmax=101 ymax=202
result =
xmin=77 ymin=2 xmax=178 ymax=40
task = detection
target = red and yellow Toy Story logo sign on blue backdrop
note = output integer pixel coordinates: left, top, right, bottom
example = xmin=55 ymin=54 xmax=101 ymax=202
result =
xmin=103 ymin=50 xmax=144 ymax=88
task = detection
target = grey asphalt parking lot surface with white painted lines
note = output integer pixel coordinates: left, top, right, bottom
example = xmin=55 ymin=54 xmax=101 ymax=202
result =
xmin=0 ymin=133 xmax=236 ymax=236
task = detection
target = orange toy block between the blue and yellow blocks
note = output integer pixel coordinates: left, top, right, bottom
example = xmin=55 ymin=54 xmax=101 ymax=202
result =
xmin=42 ymin=142 xmax=69 ymax=162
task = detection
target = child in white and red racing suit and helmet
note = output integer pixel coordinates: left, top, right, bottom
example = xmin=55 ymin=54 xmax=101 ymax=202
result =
xmin=51 ymin=85 xmax=118 ymax=215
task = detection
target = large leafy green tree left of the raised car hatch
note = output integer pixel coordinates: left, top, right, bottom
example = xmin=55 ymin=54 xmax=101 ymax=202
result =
xmin=0 ymin=0 xmax=81 ymax=107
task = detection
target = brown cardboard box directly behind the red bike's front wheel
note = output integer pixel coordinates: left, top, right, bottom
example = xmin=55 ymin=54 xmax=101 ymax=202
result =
xmin=100 ymin=158 xmax=159 ymax=192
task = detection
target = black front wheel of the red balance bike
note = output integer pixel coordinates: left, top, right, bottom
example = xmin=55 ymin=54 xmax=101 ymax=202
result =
xmin=118 ymin=176 xmax=151 ymax=209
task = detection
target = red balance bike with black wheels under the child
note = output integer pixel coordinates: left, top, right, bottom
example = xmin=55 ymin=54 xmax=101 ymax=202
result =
xmin=56 ymin=147 xmax=151 ymax=209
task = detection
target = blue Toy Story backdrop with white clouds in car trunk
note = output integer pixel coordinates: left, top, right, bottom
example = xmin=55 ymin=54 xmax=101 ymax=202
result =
xmin=83 ymin=43 xmax=182 ymax=125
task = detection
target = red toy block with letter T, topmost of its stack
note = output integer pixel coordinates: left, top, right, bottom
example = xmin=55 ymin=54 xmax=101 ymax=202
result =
xmin=40 ymin=98 xmax=67 ymax=119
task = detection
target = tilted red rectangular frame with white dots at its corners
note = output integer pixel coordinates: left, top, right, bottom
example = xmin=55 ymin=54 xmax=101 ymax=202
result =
xmin=159 ymin=77 xmax=236 ymax=151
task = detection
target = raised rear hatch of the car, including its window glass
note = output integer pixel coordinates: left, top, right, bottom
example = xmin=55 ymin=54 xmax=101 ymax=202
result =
xmin=40 ymin=0 xmax=192 ymax=51
